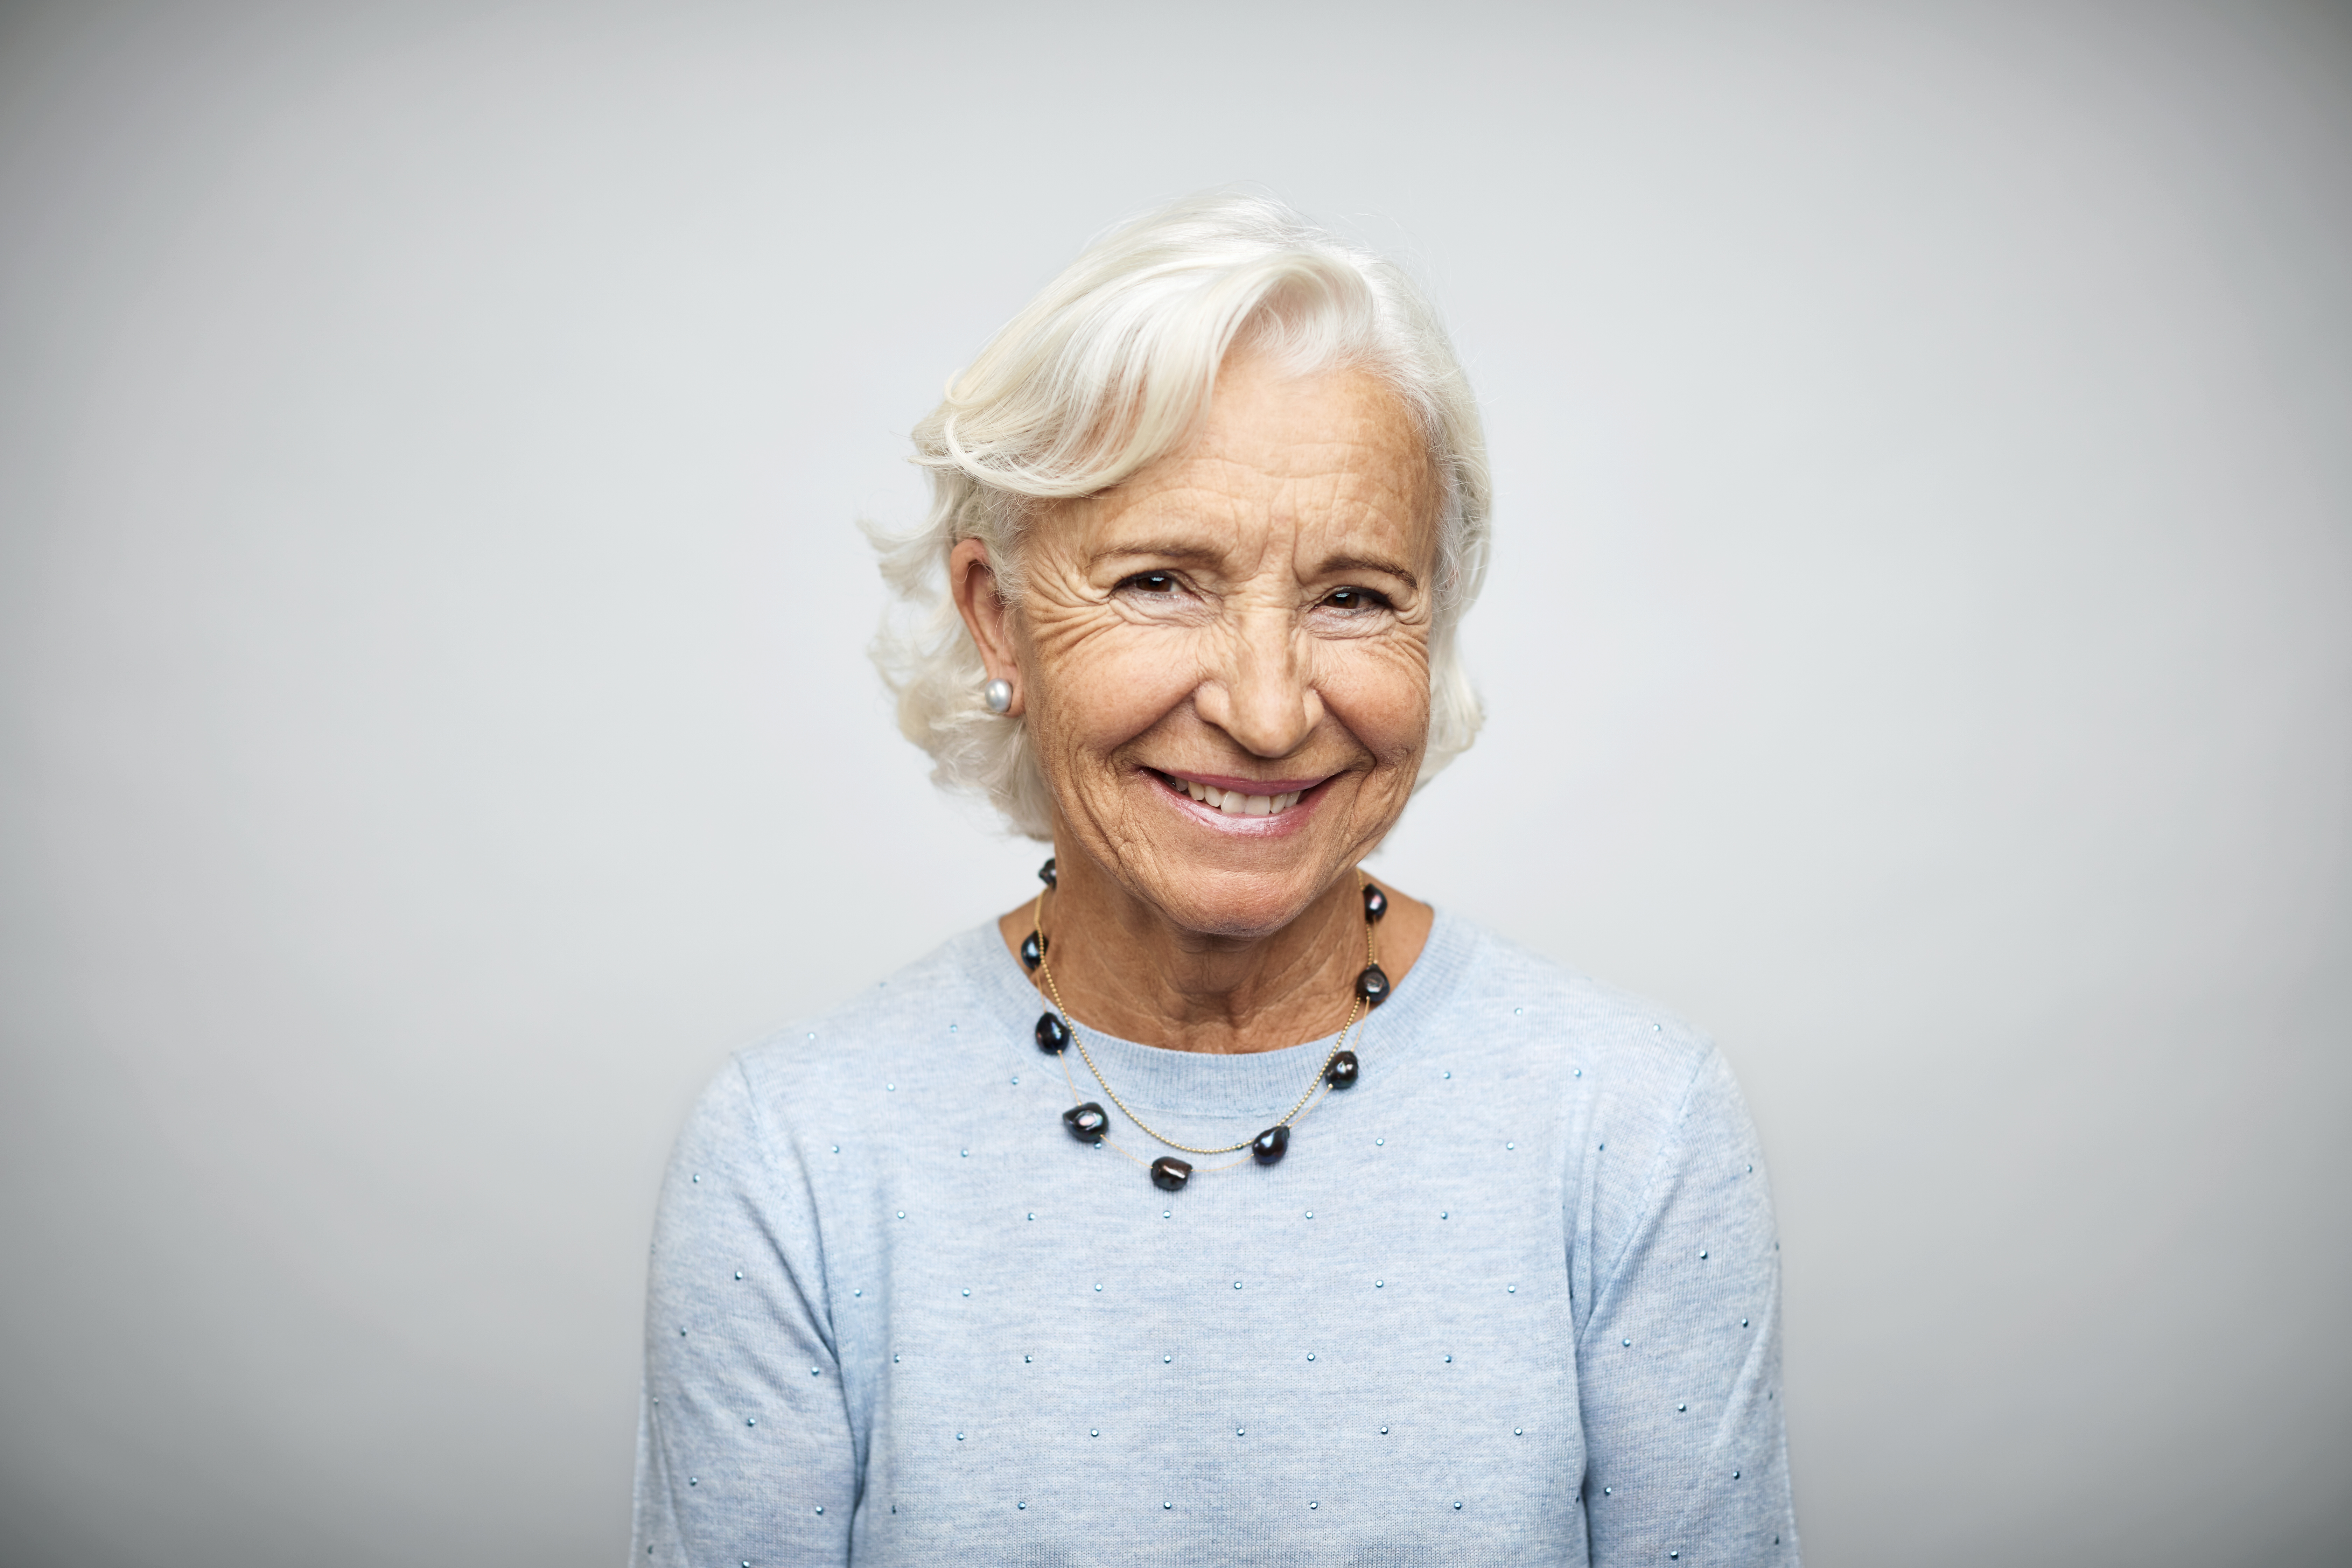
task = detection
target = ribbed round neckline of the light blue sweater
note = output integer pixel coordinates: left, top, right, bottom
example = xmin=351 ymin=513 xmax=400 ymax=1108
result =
xmin=960 ymin=910 xmax=1470 ymax=1133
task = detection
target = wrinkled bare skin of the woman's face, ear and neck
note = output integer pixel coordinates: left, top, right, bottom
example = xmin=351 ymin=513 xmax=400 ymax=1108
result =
xmin=950 ymin=355 xmax=1440 ymax=1051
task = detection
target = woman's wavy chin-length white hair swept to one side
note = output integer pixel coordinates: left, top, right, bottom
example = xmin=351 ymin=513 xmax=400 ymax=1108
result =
xmin=870 ymin=193 xmax=1491 ymax=839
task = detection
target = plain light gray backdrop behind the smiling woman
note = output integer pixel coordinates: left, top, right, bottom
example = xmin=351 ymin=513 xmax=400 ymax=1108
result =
xmin=0 ymin=0 xmax=2352 ymax=1568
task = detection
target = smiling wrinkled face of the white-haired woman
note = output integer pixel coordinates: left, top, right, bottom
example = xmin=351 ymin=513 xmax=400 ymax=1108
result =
xmin=967 ymin=357 xmax=1440 ymax=938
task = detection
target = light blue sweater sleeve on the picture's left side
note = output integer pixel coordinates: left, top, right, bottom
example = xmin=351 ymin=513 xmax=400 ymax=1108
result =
xmin=630 ymin=1065 xmax=859 ymax=1568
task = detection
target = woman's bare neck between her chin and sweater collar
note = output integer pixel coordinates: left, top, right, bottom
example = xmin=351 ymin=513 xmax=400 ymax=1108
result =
xmin=997 ymin=856 xmax=1435 ymax=1056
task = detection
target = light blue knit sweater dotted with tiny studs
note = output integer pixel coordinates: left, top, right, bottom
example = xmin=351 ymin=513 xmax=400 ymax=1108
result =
xmin=630 ymin=915 xmax=1797 ymax=1568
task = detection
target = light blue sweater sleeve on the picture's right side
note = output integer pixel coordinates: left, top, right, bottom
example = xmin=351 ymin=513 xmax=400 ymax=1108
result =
xmin=1576 ymin=1049 xmax=1797 ymax=1568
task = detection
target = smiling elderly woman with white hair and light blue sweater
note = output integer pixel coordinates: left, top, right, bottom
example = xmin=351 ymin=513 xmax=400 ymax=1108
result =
xmin=633 ymin=195 xmax=1797 ymax=1568
